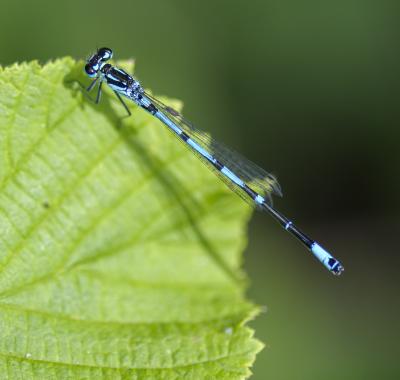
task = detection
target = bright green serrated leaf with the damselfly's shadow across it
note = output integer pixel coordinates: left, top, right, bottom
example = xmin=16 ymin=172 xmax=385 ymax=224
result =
xmin=0 ymin=58 xmax=262 ymax=380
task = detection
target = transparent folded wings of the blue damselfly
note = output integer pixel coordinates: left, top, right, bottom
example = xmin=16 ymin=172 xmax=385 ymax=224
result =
xmin=145 ymin=93 xmax=282 ymax=203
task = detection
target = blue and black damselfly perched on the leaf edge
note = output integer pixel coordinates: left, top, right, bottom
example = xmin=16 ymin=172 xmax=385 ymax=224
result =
xmin=85 ymin=48 xmax=343 ymax=275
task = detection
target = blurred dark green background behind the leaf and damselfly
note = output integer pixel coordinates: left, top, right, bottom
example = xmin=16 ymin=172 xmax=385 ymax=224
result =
xmin=0 ymin=0 xmax=400 ymax=380
